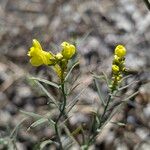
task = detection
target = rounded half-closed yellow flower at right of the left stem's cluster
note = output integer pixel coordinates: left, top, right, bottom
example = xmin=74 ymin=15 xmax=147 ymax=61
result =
xmin=61 ymin=42 xmax=76 ymax=60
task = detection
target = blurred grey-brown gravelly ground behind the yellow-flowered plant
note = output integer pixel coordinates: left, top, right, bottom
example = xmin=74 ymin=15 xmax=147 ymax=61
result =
xmin=0 ymin=0 xmax=150 ymax=150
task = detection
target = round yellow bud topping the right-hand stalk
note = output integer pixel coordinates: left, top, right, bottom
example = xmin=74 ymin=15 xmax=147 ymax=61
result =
xmin=115 ymin=45 xmax=126 ymax=58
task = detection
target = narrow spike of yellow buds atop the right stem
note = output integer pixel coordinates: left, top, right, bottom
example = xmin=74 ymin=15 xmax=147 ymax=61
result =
xmin=110 ymin=45 xmax=126 ymax=91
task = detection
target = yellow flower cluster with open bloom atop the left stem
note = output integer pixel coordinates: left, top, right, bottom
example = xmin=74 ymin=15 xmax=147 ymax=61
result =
xmin=27 ymin=39 xmax=76 ymax=79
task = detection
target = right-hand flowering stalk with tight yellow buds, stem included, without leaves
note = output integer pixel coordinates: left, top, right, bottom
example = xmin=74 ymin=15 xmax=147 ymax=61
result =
xmin=84 ymin=45 xmax=126 ymax=150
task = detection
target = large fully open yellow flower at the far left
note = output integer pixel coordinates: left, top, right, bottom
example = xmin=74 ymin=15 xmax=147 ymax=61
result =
xmin=27 ymin=39 xmax=54 ymax=66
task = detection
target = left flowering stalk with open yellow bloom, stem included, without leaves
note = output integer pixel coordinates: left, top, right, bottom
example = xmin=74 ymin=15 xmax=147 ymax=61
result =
xmin=28 ymin=39 xmax=76 ymax=150
